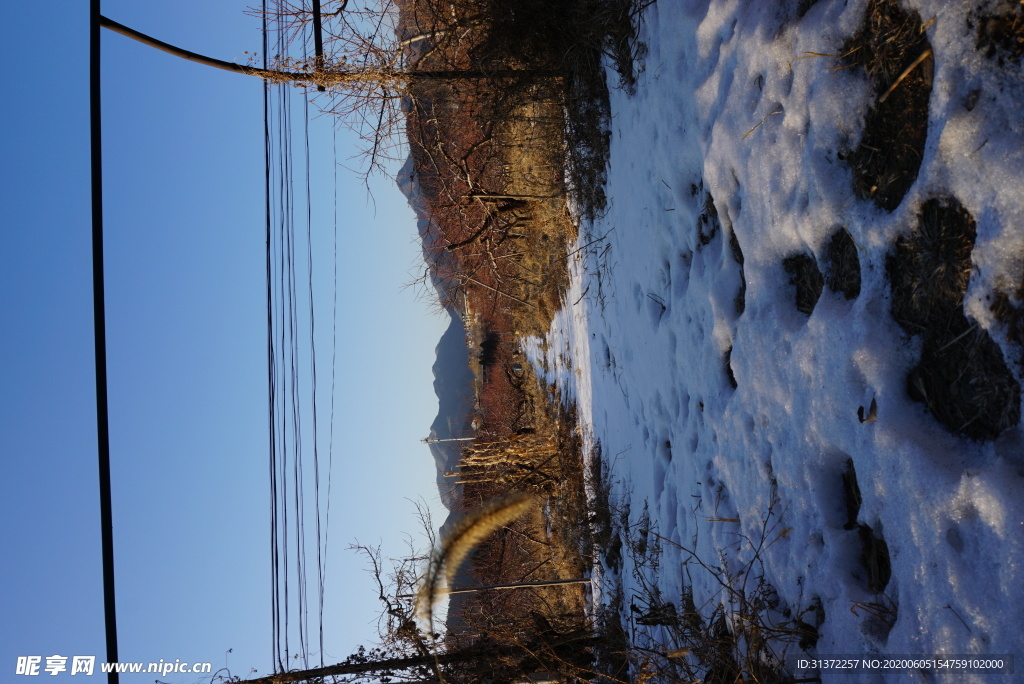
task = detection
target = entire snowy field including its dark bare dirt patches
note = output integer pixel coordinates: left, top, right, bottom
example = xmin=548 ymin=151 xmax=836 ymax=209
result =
xmin=530 ymin=0 xmax=1024 ymax=682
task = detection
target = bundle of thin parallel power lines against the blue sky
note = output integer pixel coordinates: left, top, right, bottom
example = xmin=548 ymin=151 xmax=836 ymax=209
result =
xmin=263 ymin=7 xmax=338 ymax=671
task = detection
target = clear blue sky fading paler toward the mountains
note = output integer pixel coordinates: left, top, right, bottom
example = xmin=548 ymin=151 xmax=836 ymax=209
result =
xmin=0 ymin=0 xmax=447 ymax=682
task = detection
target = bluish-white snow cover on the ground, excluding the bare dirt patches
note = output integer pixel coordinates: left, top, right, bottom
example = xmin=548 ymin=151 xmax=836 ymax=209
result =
xmin=527 ymin=0 xmax=1024 ymax=682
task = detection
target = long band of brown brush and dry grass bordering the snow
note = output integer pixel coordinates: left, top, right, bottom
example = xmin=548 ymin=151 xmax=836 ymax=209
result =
xmin=382 ymin=0 xmax=637 ymax=682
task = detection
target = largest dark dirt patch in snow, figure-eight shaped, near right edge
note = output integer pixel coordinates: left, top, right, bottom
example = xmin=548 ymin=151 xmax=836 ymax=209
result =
xmin=886 ymin=198 xmax=1020 ymax=439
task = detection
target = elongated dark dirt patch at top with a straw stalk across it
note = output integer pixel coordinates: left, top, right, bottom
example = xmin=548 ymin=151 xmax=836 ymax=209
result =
xmin=841 ymin=0 xmax=934 ymax=211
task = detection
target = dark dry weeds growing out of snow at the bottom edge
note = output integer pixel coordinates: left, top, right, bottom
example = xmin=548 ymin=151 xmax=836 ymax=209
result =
xmin=577 ymin=462 xmax=824 ymax=684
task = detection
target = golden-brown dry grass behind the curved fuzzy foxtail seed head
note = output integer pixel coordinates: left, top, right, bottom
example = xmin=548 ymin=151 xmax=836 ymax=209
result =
xmin=449 ymin=382 xmax=593 ymax=655
